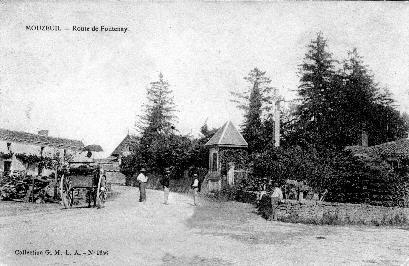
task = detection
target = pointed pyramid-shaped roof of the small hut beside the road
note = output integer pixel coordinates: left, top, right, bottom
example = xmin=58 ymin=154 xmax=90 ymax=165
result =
xmin=205 ymin=121 xmax=248 ymax=148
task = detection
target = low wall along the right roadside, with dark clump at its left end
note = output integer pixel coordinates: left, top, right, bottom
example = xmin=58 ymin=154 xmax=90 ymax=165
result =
xmin=258 ymin=196 xmax=409 ymax=225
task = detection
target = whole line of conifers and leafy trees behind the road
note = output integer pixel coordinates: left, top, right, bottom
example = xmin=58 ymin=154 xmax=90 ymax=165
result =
xmin=121 ymin=33 xmax=409 ymax=205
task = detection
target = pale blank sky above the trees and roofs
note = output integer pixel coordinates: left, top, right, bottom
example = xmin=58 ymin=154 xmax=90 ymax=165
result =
xmin=0 ymin=1 xmax=409 ymax=155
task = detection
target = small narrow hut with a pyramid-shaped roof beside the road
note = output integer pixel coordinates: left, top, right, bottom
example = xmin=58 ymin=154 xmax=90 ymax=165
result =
xmin=205 ymin=121 xmax=248 ymax=190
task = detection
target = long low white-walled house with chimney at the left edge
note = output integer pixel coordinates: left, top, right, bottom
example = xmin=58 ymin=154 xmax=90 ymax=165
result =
xmin=0 ymin=129 xmax=84 ymax=178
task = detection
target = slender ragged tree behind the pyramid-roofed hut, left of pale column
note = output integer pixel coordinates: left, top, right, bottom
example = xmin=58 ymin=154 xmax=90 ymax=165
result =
xmin=231 ymin=68 xmax=273 ymax=152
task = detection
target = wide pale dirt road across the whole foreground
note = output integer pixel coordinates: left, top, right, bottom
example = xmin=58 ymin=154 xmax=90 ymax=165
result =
xmin=0 ymin=187 xmax=409 ymax=265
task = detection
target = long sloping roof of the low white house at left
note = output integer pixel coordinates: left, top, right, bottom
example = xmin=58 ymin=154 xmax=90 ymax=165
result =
xmin=0 ymin=128 xmax=84 ymax=150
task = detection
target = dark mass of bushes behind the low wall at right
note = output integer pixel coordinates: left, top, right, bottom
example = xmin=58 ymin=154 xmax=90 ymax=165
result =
xmin=250 ymin=143 xmax=409 ymax=206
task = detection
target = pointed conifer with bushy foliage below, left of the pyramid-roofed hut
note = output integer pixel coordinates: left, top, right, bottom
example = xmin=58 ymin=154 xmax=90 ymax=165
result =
xmin=121 ymin=74 xmax=210 ymax=181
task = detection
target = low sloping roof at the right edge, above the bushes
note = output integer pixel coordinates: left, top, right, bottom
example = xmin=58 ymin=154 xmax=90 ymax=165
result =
xmin=345 ymin=139 xmax=409 ymax=159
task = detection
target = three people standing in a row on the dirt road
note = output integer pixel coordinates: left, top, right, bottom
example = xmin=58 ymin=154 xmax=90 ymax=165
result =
xmin=136 ymin=168 xmax=199 ymax=206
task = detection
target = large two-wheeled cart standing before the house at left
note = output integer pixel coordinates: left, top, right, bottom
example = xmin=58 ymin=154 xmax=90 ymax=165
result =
xmin=60 ymin=163 xmax=106 ymax=208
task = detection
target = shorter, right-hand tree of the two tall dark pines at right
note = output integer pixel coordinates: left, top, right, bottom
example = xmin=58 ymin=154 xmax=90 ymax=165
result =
xmin=339 ymin=48 xmax=407 ymax=145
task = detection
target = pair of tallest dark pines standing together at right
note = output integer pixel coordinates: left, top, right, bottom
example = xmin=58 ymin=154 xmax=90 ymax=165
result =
xmin=290 ymin=33 xmax=407 ymax=149
